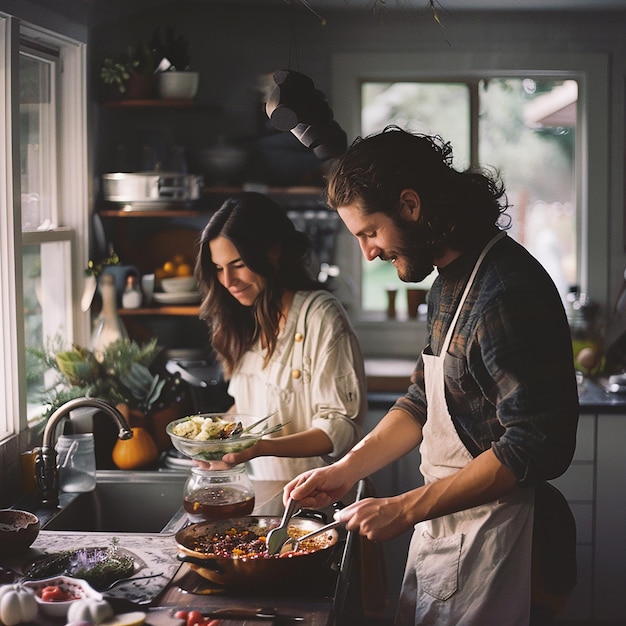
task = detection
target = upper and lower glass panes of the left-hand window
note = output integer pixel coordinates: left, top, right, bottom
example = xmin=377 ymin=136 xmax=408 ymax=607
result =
xmin=19 ymin=49 xmax=71 ymax=418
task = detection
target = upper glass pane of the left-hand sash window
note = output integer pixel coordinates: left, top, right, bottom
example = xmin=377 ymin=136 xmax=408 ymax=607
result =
xmin=20 ymin=53 xmax=56 ymax=230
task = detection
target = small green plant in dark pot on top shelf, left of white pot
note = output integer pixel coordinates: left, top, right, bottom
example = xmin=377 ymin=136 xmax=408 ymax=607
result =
xmin=100 ymin=40 xmax=156 ymax=100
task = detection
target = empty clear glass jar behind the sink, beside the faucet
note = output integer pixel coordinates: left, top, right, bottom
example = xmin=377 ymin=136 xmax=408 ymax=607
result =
xmin=55 ymin=433 xmax=96 ymax=492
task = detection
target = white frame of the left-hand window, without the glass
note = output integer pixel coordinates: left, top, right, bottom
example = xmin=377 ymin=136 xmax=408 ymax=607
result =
xmin=0 ymin=13 xmax=91 ymax=441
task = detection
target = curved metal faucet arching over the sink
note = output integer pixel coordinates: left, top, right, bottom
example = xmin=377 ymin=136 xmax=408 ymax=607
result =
xmin=35 ymin=398 xmax=133 ymax=508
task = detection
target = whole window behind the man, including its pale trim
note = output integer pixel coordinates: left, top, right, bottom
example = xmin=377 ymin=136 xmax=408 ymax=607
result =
xmin=333 ymin=53 xmax=608 ymax=357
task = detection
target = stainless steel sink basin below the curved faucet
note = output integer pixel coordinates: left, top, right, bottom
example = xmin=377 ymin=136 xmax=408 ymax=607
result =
xmin=42 ymin=470 xmax=188 ymax=533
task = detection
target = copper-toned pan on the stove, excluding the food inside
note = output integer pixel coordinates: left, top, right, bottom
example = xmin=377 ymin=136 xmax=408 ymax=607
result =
xmin=175 ymin=516 xmax=339 ymax=591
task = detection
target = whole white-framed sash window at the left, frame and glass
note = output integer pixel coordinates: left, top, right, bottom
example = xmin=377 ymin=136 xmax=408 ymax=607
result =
xmin=0 ymin=16 xmax=89 ymax=440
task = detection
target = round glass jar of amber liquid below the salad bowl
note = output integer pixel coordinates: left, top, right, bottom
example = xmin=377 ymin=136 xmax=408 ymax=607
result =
xmin=183 ymin=465 xmax=254 ymax=522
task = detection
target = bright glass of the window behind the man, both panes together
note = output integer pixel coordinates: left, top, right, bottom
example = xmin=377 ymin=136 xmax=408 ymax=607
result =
xmin=361 ymin=77 xmax=578 ymax=314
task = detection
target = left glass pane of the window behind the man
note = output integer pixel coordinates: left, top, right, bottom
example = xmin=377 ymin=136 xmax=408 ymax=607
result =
xmin=361 ymin=82 xmax=470 ymax=317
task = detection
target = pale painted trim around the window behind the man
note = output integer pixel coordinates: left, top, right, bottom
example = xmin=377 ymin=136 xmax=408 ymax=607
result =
xmin=331 ymin=52 xmax=609 ymax=358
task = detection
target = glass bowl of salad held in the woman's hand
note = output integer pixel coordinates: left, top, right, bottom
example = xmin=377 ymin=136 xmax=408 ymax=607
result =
xmin=165 ymin=413 xmax=284 ymax=461
